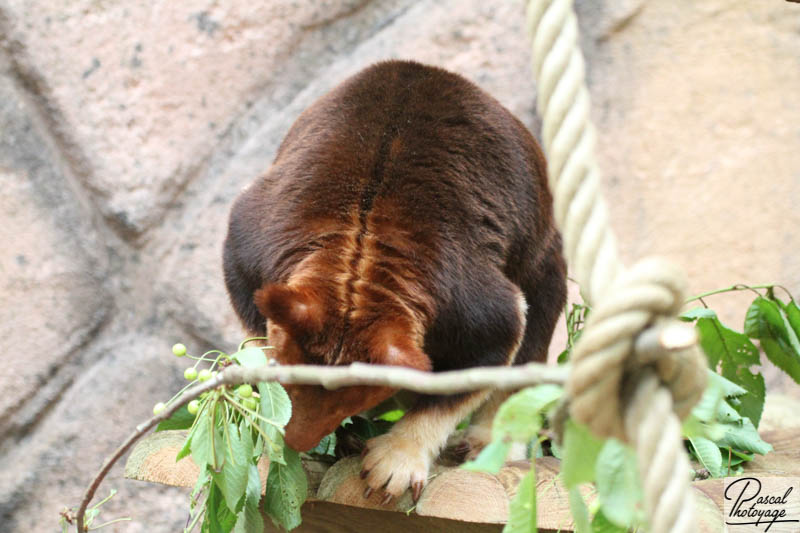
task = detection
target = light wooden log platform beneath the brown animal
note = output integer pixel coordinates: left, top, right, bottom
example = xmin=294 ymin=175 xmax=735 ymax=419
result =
xmin=125 ymin=396 xmax=800 ymax=533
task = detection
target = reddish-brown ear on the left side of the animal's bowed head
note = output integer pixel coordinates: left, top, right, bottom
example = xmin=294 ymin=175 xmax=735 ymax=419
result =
xmin=253 ymin=284 xmax=323 ymax=336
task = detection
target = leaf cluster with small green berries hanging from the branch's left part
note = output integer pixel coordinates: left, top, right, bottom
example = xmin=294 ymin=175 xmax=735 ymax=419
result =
xmin=157 ymin=341 xmax=302 ymax=533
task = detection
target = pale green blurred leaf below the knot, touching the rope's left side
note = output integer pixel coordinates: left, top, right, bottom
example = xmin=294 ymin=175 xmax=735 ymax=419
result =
xmin=595 ymin=439 xmax=642 ymax=527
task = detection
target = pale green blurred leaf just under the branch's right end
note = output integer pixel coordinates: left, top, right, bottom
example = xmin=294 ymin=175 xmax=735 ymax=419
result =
xmin=492 ymin=385 xmax=563 ymax=443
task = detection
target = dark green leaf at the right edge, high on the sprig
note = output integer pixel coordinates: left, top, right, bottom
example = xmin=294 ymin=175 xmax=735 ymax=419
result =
xmin=744 ymin=296 xmax=800 ymax=384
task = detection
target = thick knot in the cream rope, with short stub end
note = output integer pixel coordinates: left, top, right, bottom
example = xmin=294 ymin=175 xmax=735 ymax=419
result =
xmin=567 ymin=258 xmax=706 ymax=440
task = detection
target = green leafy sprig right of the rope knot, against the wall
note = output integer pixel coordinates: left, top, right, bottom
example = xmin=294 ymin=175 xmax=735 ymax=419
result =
xmin=681 ymin=285 xmax=800 ymax=477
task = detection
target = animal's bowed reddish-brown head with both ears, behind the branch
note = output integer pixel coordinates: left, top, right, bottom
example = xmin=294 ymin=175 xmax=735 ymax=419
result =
xmin=254 ymin=282 xmax=430 ymax=451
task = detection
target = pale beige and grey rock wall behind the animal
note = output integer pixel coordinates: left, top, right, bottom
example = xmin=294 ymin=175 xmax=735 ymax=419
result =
xmin=0 ymin=0 xmax=800 ymax=532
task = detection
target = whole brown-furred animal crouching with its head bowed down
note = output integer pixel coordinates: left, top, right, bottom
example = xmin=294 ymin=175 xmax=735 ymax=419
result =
xmin=224 ymin=61 xmax=565 ymax=499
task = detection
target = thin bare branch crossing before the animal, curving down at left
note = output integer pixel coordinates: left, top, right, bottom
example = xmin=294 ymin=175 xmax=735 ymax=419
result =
xmin=76 ymin=363 xmax=569 ymax=533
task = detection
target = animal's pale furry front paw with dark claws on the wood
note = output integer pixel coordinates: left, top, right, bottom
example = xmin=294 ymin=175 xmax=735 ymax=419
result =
xmin=361 ymin=432 xmax=431 ymax=504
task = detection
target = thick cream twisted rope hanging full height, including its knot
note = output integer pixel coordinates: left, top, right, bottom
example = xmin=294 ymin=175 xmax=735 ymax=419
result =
xmin=527 ymin=0 xmax=706 ymax=533
